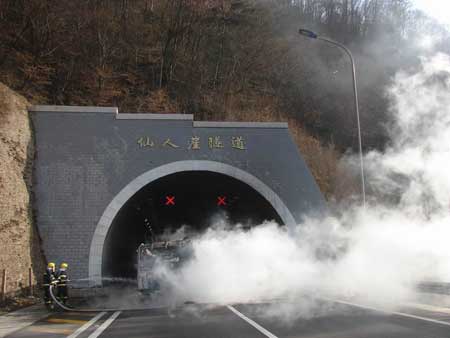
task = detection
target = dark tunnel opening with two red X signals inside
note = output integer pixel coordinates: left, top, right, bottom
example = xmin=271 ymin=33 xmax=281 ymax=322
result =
xmin=102 ymin=171 xmax=283 ymax=279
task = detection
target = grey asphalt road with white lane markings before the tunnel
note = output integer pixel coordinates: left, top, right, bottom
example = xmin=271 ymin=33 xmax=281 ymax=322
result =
xmin=8 ymin=300 xmax=450 ymax=338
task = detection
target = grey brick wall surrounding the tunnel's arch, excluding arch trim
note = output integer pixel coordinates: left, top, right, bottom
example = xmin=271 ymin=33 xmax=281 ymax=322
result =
xmin=30 ymin=106 xmax=325 ymax=286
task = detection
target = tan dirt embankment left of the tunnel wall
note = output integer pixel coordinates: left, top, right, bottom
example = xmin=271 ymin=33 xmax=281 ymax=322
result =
xmin=0 ymin=83 xmax=43 ymax=304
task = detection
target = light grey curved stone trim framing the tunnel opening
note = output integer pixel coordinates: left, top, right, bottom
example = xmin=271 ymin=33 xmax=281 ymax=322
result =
xmin=89 ymin=160 xmax=295 ymax=286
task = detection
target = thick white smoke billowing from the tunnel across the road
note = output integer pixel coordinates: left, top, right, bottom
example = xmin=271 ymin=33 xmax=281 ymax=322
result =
xmin=152 ymin=55 xmax=450 ymax=313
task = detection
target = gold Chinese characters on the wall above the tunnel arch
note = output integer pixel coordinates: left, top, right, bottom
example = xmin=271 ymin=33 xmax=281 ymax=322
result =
xmin=137 ymin=136 xmax=246 ymax=150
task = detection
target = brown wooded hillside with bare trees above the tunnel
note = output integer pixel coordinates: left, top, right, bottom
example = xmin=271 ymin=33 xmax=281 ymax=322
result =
xmin=0 ymin=0 xmax=450 ymax=152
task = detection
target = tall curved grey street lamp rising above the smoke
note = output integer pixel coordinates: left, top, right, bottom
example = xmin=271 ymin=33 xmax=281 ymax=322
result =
xmin=298 ymin=28 xmax=366 ymax=208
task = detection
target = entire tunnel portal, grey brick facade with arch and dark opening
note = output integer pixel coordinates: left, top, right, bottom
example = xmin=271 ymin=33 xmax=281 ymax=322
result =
xmin=30 ymin=106 xmax=325 ymax=287
